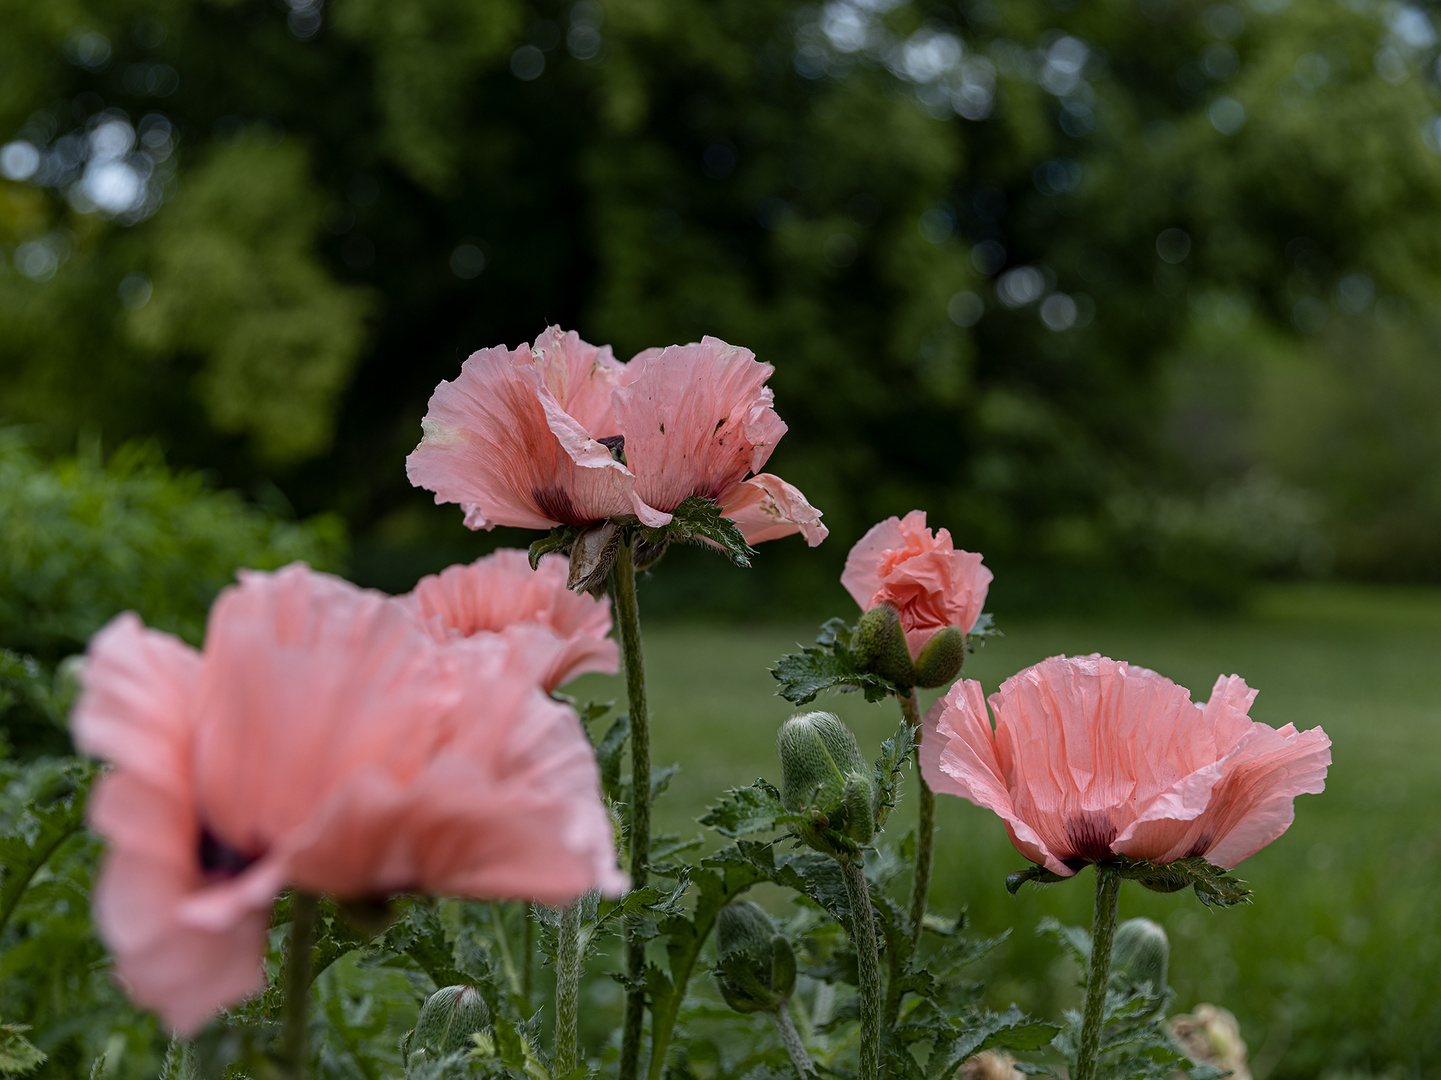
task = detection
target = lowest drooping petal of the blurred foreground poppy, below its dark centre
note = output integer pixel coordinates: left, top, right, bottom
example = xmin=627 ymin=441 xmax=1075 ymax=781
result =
xmin=89 ymin=769 xmax=274 ymax=1035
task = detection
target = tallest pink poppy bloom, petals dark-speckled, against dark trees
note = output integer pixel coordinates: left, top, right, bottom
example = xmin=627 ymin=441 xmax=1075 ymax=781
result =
xmin=405 ymin=326 xmax=827 ymax=546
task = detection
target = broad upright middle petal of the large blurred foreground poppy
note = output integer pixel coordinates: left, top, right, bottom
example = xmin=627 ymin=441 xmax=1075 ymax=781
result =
xmin=195 ymin=564 xmax=461 ymax=855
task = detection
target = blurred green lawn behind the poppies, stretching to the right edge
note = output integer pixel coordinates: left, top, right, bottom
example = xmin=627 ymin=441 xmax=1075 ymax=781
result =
xmin=574 ymin=585 xmax=1441 ymax=1080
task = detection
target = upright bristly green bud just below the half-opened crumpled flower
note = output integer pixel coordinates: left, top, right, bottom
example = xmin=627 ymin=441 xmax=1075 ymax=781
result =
xmin=777 ymin=712 xmax=876 ymax=855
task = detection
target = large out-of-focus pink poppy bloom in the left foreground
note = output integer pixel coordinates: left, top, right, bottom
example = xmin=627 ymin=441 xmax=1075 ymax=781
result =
xmin=73 ymin=564 xmax=625 ymax=1034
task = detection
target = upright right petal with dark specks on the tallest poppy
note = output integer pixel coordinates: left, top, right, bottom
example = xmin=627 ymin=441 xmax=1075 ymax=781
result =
xmin=612 ymin=337 xmax=785 ymax=512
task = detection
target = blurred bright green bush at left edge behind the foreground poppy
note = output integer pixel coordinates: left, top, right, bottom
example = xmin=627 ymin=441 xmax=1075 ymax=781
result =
xmin=0 ymin=430 xmax=342 ymax=662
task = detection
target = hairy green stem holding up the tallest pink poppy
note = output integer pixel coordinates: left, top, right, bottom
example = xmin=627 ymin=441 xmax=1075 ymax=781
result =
xmin=611 ymin=536 xmax=650 ymax=1080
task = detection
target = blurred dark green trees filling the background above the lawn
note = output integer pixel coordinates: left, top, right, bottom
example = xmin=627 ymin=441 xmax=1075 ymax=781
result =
xmin=0 ymin=0 xmax=1441 ymax=603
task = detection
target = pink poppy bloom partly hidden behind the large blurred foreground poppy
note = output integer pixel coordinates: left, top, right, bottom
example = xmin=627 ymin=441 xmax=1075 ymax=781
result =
xmin=398 ymin=548 xmax=621 ymax=692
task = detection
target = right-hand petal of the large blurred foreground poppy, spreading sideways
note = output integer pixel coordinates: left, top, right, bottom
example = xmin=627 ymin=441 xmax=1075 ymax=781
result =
xmin=275 ymin=637 xmax=624 ymax=904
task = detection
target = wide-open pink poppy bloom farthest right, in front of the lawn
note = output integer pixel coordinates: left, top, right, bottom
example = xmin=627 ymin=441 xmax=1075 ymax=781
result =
xmin=921 ymin=656 xmax=1331 ymax=877
